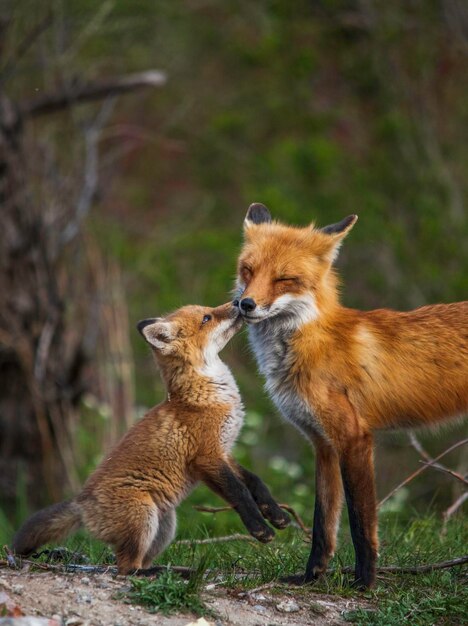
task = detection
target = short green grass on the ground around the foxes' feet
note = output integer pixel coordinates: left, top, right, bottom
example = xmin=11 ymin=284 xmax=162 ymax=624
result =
xmin=1 ymin=512 xmax=468 ymax=626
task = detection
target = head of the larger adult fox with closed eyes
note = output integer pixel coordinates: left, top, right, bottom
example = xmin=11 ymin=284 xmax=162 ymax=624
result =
xmin=234 ymin=204 xmax=357 ymax=324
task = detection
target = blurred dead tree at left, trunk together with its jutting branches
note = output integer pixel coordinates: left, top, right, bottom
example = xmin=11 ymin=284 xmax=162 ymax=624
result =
xmin=0 ymin=66 xmax=164 ymax=509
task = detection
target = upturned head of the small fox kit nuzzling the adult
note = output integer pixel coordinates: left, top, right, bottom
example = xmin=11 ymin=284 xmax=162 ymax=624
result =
xmin=137 ymin=303 xmax=242 ymax=368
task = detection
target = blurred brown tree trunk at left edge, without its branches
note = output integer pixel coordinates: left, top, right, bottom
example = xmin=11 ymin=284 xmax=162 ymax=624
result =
xmin=0 ymin=91 xmax=85 ymax=504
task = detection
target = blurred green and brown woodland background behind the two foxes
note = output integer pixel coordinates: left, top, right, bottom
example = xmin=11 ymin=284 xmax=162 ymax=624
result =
xmin=0 ymin=0 xmax=468 ymax=541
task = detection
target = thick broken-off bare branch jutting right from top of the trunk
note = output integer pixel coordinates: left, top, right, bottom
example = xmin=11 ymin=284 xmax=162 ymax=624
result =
xmin=19 ymin=70 xmax=166 ymax=117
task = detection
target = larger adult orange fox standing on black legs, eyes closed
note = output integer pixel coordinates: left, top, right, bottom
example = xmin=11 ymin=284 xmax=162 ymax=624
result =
xmin=234 ymin=204 xmax=468 ymax=587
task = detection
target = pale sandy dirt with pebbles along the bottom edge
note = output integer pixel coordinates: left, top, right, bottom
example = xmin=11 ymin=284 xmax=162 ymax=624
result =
xmin=0 ymin=569 xmax=370 ymax=626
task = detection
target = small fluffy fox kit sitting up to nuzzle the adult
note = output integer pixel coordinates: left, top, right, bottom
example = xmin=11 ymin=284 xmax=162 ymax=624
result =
xmin=13 ymin=304 xmax=289 ymax=574
